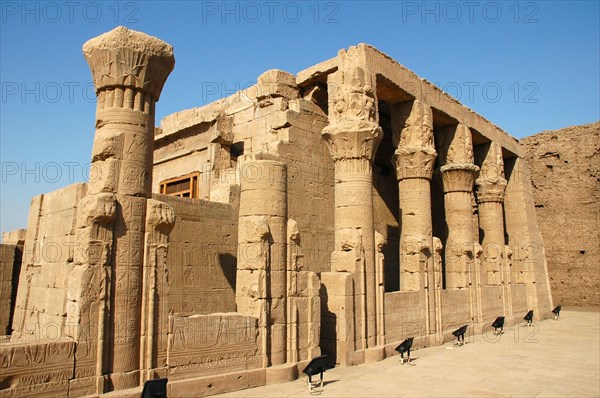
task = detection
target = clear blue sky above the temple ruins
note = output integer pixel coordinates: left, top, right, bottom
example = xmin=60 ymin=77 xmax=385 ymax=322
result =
xmin=0 ymin=0 xmax=600 ymax=235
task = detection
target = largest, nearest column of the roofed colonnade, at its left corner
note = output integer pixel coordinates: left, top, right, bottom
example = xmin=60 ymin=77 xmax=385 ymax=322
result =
xmin=322 ymin=56 xmax=383 ymax=349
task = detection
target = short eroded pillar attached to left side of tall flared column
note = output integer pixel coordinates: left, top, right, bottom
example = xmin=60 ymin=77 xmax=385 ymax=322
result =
xmin=65 ymin=193 xmax=117 ymax=395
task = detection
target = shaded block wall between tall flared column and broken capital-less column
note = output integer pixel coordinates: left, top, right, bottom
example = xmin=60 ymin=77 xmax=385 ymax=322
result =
xmin=158 ymin=194 xmax=238 ymax=315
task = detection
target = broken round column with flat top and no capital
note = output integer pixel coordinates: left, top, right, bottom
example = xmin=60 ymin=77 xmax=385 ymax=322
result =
xmin=236 ymin=158 xmax=287 ymax=366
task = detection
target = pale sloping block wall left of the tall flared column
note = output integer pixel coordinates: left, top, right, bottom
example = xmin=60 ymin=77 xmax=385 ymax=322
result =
xmin=13 ymin=184 xmax=86 ymax=341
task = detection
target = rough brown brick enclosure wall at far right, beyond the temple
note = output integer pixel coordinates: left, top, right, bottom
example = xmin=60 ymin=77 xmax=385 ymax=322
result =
xmin=521 ymin=122 xmax=600 ymax=306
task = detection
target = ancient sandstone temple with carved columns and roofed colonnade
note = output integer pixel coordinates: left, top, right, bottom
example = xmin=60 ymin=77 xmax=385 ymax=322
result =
xmin=0 ymin=27 xmax=552 ymax=397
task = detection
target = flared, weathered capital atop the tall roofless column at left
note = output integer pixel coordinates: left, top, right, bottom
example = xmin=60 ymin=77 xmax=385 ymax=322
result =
xmin=83 ymin=26 xmax=175 ymax=101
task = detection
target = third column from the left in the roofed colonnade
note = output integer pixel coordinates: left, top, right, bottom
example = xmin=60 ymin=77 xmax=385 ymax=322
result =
xmin=440 ymin=124 xmax=479 ymax=289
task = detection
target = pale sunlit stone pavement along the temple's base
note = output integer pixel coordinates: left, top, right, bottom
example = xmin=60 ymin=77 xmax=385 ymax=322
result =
xmin=215 ymin=309 xmax=600 ymax=397
